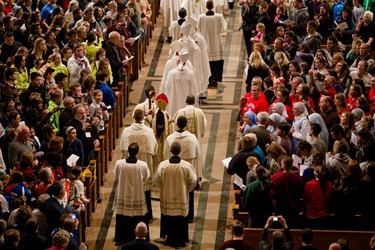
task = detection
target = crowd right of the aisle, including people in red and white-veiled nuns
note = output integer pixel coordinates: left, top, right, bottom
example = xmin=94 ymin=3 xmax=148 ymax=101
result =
xmin=232 ymin=0 xmax=375 ymax=238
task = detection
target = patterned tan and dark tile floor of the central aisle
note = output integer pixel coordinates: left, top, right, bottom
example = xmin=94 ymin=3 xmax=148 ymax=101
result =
xmin=86 ymin=6 xmax=246 ymax=250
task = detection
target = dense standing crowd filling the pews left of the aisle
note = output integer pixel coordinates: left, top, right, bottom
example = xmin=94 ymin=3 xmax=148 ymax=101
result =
xmin=0 ymin=0 xmax=156 ymax=249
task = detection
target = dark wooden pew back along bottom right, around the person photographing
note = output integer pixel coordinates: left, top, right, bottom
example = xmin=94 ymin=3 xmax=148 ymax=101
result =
xmin=244 ymin=228 xmax=375 ymax=250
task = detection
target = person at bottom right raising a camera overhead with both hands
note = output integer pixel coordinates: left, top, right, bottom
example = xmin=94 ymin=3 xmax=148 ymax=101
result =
xmin=259 ymin=215 xmax=294 ymax=250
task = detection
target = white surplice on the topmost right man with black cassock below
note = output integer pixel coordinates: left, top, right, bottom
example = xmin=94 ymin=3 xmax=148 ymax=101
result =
xmin=198 ymin=13 xmax=227 ymax=61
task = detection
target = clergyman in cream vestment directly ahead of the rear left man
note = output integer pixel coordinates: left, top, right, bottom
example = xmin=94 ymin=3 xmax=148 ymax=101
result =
xmin=120 ymin=109 xmax=159 ymax=219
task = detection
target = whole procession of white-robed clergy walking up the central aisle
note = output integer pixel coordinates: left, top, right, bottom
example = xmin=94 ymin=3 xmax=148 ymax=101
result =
xmin=114 ymin=0 xmax=227 ymax=248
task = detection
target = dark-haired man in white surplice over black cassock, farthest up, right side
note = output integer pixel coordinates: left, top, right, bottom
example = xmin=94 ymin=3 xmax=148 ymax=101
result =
xmin=198 ymin=0 xmax=227 ymax=86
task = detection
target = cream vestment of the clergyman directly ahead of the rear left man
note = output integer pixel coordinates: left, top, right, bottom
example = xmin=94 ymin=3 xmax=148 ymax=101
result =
xmin=120 ymin=123 xmax=158 ymax=190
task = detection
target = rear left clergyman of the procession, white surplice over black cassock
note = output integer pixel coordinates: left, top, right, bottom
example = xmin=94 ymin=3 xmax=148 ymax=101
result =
xmin=113 ymin=142 xmax=150 ymax=245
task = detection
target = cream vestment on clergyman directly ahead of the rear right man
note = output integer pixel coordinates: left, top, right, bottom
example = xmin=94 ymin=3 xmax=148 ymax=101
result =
xmin=164 ymin=130 xmax=203 ymax=178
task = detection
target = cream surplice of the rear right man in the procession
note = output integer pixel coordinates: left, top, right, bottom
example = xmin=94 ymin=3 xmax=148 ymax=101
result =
xmin=153 ymin=160 xmax=197 ymax=217
